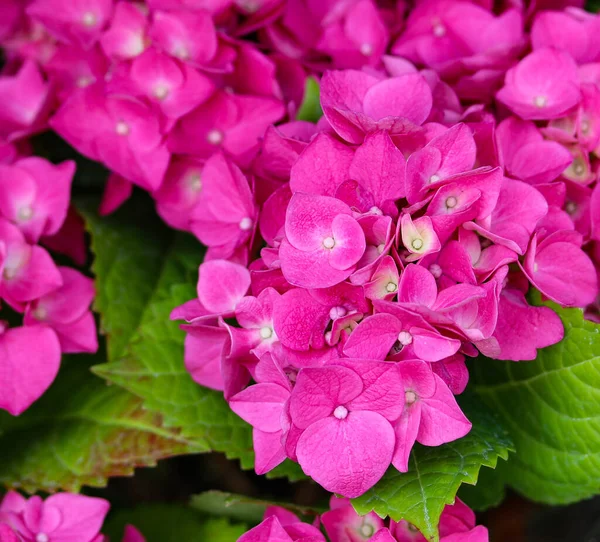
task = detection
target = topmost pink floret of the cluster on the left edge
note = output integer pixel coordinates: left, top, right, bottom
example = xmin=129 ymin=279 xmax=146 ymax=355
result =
xmin=0 ymin=157 xmax=75 ymax=243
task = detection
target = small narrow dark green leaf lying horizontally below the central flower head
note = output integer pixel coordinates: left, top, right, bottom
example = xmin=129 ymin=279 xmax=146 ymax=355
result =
xmin=190 ymin=491 xmax=326 ymax=524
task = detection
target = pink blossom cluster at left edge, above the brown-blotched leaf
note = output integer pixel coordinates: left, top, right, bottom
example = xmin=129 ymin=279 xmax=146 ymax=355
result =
xmin=0 ymin=152 xmax=98 ymax=415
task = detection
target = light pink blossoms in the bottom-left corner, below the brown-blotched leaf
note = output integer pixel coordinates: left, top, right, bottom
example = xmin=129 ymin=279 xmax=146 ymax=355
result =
xmin=0 ymin=491 xmax=145 ymax=542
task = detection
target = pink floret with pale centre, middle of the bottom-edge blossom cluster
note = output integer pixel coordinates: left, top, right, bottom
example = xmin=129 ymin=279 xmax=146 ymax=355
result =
xmin=321 ymin=496 xmax=384 ymax=542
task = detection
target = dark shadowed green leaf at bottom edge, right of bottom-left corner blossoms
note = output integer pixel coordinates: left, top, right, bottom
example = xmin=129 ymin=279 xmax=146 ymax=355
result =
xmin=104 ymin=504 xmax=248 ymax=542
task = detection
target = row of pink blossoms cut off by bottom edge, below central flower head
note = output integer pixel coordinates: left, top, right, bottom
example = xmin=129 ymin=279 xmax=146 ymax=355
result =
xmin=238 ymin=497 xmax=489 ymax=542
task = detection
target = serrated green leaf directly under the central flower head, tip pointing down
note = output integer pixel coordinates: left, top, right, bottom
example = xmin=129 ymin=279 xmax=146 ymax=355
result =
xmin=352 ymin=396 xmax=512 ymax=541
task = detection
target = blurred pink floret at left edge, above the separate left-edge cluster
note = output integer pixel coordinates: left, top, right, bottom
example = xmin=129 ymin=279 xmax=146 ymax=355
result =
xmin=0 ymin=60 xmax=50 ymax=140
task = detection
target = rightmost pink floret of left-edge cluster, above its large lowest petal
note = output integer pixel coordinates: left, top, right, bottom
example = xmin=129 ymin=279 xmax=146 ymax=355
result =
xmin=24 ymin=267 xmax=98 ymax=354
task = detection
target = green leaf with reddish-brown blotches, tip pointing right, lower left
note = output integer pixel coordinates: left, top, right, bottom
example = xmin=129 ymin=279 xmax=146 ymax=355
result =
xmin=0 ymin=356 xmax=204 ymax=493
